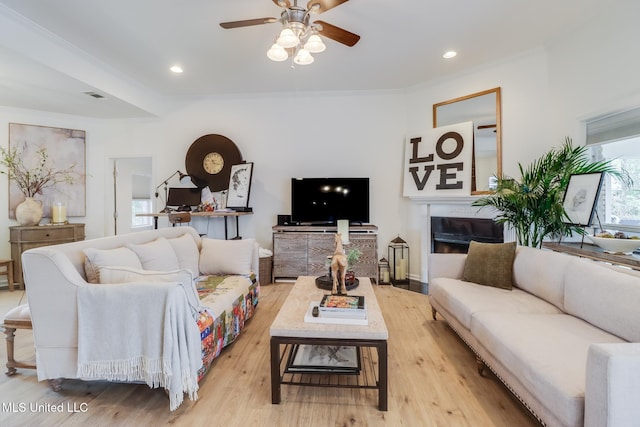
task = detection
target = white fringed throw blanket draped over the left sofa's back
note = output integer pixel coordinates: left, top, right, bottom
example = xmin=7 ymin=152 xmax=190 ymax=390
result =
xmin=78 ymin=283 xmax=202 ymax=411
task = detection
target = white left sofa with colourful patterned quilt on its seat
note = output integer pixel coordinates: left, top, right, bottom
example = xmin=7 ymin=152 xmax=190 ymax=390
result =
xmin=22 ymin=227 xmax=259 ymax=400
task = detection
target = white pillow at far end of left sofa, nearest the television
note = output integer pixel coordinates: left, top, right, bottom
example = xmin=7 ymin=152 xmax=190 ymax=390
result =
xmin=200 ymin=238 xmax=255 ymax=275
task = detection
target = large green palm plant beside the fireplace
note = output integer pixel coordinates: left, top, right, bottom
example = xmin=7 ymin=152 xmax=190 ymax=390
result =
xmin=473 ymin=137 xmax=630 ymax=247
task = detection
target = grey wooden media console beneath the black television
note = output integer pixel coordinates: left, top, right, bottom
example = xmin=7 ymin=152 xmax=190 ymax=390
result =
xmin=272 ymin=224 xmax=378 ymax=282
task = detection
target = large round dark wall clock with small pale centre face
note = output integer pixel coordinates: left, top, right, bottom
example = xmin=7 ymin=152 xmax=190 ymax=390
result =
xmin=185 ymin=134 xmax=242 ymax=192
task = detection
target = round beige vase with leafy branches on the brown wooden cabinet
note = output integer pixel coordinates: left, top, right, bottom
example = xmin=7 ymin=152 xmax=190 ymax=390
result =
xmin=0 ymin=146 xmax=79 ymax=225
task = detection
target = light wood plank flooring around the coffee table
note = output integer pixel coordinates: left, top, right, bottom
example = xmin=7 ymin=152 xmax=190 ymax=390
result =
xmin=0 ymin=283 xmax=539 ymax=427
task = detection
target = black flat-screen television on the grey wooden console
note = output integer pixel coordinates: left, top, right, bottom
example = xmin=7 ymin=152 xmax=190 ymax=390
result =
xmin=291 ymin=178 xmax=369 ymax=224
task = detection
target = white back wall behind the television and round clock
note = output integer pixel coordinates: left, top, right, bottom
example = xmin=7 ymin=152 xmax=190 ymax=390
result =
xmin=63 ymin=92 xmax=406 ymax=254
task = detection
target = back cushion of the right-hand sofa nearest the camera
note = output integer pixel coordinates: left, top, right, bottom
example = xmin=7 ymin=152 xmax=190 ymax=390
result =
xmin=564 ymin=258 xmax=640 ymax=342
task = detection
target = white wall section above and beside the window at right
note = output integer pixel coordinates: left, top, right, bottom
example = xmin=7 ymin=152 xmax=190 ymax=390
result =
xmin=548 ymin=0 xmax=640 ymax=136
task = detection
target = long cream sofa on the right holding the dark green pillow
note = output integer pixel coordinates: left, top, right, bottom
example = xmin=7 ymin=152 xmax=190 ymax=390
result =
xmin=428 ymin=247 xmax=640 ymax=427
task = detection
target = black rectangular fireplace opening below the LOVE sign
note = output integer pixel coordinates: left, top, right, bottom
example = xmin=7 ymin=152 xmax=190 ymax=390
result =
xmin=431 ymin=216 xmax=504 ymax=254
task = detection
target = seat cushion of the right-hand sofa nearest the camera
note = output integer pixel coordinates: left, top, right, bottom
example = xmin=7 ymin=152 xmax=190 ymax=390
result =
xmin=471 ymin=312 xmax=622 ymax=426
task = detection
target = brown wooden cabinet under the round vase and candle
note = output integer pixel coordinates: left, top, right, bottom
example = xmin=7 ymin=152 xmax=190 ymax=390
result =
xmin=9 ymin=224 xmax=84 ymax=283
